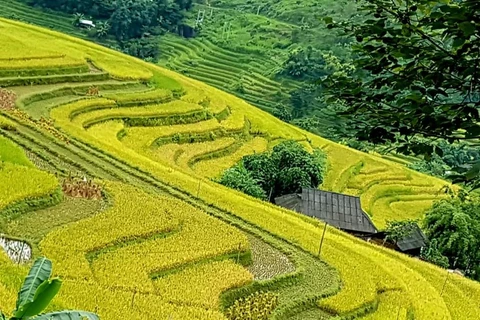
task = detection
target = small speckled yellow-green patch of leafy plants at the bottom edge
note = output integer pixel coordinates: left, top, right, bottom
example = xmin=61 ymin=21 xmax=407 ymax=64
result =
xmin=225 ymin=291 xmax=278 ymax=320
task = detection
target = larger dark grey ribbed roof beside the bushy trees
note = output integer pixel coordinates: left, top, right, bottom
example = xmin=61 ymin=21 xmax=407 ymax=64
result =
xmin=275 ymin=188 xmax=377 ymax=233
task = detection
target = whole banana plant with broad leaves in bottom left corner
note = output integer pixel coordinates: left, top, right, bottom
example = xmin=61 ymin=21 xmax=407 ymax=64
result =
xmin=0 ymin=257 xmax=100 ymax=320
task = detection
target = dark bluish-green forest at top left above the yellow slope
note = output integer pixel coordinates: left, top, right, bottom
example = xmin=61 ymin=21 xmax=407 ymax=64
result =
xmin=26 ymin=0 xmax=192 ymax=59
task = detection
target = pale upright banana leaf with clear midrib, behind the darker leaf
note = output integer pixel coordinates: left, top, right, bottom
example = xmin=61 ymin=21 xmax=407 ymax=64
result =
xmin=16 ymin=257 xmax=52 ymax=310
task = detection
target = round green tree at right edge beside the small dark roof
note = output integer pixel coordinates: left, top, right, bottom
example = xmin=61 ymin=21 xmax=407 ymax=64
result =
xmin=424 ymin=196 xmax=480 ymax=280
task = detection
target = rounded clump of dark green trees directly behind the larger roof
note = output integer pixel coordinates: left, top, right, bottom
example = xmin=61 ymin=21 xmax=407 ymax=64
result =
xmin=220 ymin=140 xmax=326 ymax=201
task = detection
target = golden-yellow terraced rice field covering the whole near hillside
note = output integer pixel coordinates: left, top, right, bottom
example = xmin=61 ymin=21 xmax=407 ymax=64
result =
xmin=0 ymin=19 xmax=480 ymax=320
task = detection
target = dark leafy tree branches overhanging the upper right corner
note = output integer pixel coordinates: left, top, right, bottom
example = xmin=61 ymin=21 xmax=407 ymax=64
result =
xmin=321 ymin=0 xmax=480 ymax=164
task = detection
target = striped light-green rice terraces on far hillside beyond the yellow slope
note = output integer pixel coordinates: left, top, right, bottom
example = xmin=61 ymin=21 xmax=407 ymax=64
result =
xmin=160 ymin=35 xmax=299 ymax=111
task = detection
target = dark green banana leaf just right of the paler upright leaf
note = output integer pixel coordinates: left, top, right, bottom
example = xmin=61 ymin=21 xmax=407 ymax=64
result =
xmin=13 ymin=279 xmax=62 ymax=319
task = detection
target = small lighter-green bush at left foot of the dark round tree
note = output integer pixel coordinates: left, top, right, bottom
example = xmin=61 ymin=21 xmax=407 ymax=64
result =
xmin=219 ymin=165 xmax=267 ymax=200
